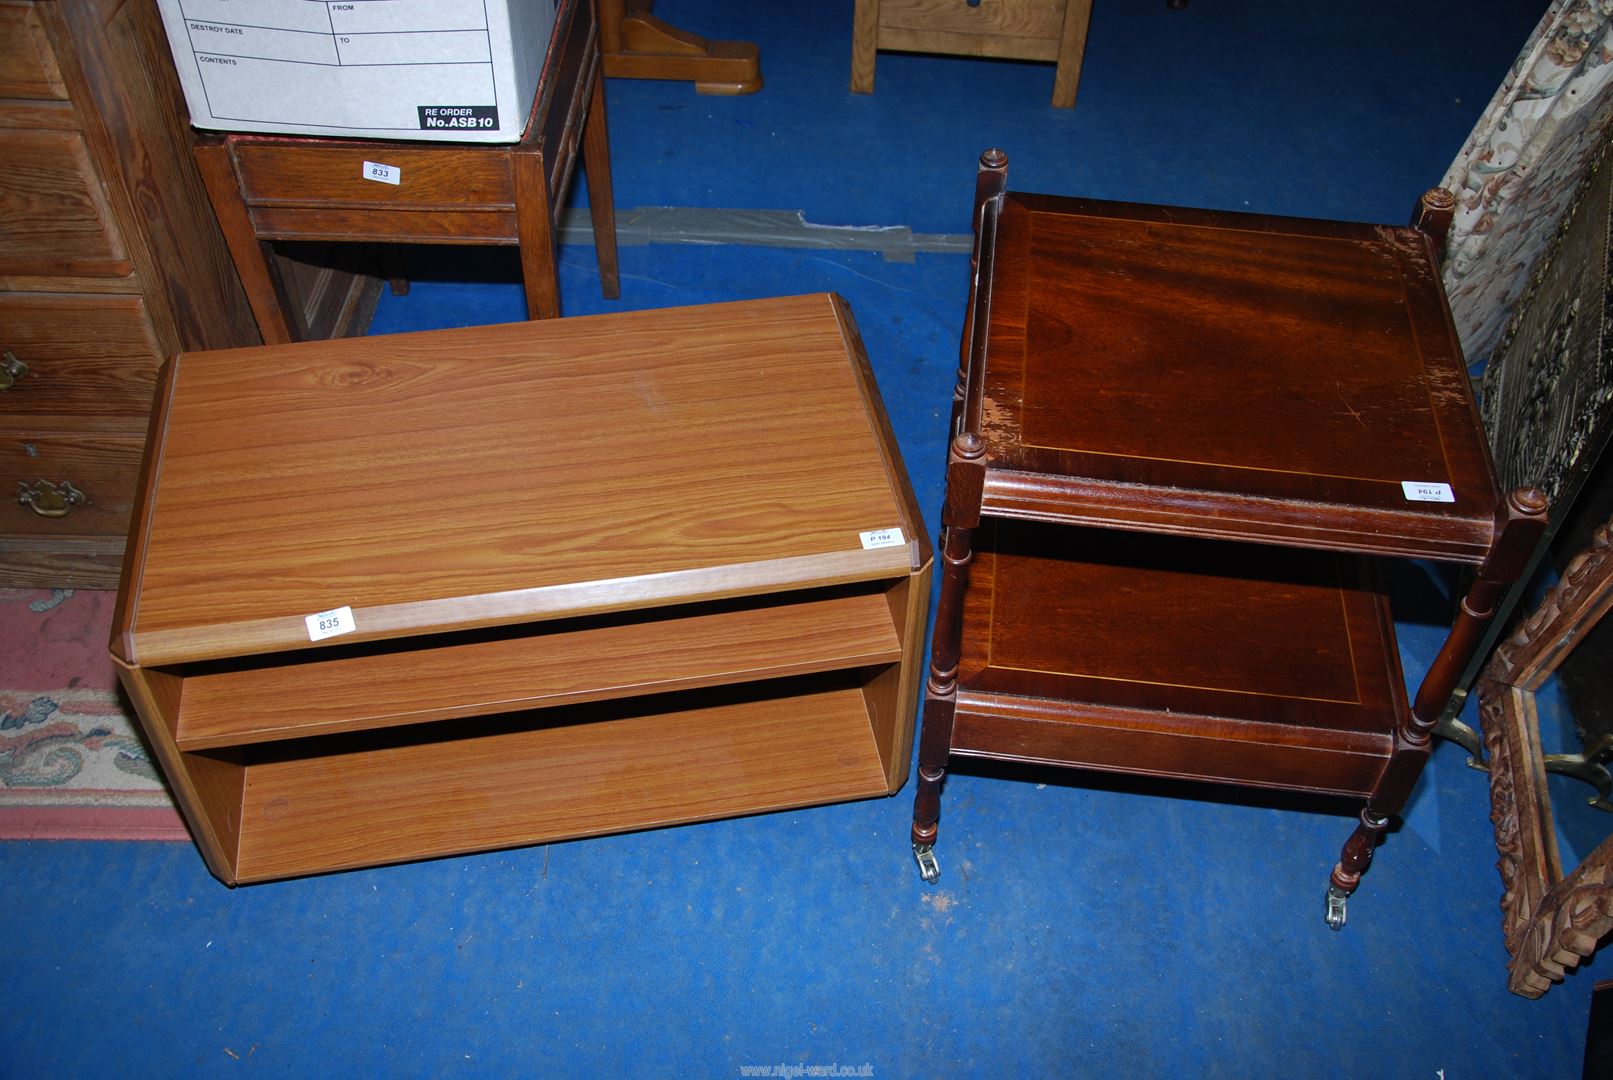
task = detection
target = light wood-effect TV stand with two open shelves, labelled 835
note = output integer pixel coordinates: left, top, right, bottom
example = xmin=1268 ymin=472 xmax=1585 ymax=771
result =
xmin=113 ymin=295 xmax=931 ymax=883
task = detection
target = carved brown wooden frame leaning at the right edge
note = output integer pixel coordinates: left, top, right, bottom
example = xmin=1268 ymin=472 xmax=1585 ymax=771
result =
xmin=1478 ymin=521 xmax=1613 ymax=998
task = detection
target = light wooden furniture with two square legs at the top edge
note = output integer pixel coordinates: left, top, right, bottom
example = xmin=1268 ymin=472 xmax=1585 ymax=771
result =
xmin=852 ymin=0 xmax=1092 ymax=108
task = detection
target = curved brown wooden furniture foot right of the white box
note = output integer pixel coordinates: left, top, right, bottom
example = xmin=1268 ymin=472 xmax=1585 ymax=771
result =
xmin=598 ymin=0 xmax=761 ymax=95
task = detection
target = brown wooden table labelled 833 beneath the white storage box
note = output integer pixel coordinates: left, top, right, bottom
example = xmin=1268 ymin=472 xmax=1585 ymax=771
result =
xmin=195 ymin=0 xmax=619 ymax=343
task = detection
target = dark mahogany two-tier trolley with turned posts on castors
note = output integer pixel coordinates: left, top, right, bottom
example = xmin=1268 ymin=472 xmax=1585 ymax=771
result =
xmin=913 ymin=152 xmax=1545 ymax=928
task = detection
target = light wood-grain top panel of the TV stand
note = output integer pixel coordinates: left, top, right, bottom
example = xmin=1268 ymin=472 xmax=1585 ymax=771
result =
xmin=115 ymin=295 xmax=927 ymax=664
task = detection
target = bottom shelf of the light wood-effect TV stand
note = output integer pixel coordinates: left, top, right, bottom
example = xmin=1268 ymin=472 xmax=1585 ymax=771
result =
xmin=201 ymin=672 xmax=889 ymax=883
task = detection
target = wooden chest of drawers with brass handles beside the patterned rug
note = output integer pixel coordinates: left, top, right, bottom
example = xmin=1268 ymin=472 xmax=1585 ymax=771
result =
xmin=0 ymin=0 xmax=258 ymax=588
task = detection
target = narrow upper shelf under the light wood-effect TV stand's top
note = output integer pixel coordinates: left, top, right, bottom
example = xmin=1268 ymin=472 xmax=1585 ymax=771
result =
xmin=175 ymin=590 xmax=902 ymax=750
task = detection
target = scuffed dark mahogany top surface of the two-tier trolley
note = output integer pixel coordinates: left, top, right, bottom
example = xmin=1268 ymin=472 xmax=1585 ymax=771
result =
xmin=973 ymin=193 xmax=1497 ymax=558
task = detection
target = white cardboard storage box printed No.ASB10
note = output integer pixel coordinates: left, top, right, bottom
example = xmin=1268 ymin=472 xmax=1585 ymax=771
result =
xmin=158 ymin=0 xmax=555 ymax=142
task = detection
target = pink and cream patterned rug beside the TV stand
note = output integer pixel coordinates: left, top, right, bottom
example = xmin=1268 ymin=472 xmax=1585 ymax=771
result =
xmin=0 ymin=588 xmax=189 ymax=840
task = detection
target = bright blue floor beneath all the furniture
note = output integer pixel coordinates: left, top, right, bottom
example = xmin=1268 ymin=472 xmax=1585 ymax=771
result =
xmin=0 ymin=0 xmax=1607 ymax=1080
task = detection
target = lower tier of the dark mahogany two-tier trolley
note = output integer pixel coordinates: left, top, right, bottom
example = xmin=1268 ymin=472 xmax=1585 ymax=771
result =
xmin=952 ymin=522 xmax=1407 ymax=795
